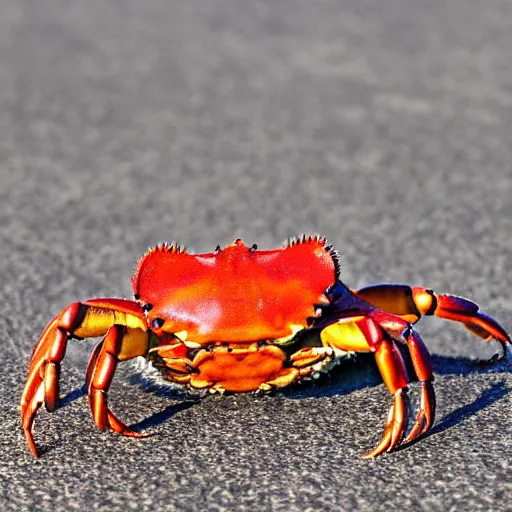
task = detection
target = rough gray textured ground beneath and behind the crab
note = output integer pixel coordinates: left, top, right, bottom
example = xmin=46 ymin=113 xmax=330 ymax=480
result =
xmin=0 ymin=0 xmax=512 ymax=510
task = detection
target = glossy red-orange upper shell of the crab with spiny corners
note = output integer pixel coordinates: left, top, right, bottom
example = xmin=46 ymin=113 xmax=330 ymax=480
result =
xmin=133 ymin=236 xmax=338 ymax=343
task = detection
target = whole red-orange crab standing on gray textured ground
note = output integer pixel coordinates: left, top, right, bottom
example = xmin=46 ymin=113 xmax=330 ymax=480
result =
xmin=21 ymin=235 xmax=511 ymax=458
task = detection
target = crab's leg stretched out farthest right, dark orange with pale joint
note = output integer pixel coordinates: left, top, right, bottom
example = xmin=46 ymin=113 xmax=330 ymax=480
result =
xmin=354 ymin=284 xmax=512 ymax=360
